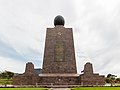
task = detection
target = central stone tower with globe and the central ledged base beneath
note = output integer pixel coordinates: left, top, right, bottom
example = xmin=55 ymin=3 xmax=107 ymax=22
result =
xmin=39 ymin=15 xmax=79 ymax=85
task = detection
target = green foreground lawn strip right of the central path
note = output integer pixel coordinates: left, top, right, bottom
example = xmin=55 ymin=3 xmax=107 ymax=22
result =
xmin=71 ymin=87 xmax=120 ymax=90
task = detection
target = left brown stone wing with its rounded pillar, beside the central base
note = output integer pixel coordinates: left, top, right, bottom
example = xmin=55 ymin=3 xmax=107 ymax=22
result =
xmin=13 ymin=62 xmax=39 ymax=85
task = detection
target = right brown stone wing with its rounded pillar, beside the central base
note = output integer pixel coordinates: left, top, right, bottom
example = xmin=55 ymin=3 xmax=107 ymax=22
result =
xmin=80 ymin=62 xmax=105 ymax=86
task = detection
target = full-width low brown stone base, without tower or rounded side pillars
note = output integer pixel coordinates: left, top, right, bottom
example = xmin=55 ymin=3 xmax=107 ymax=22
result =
xmin=13 ymin=74 xmax=105 ymax=87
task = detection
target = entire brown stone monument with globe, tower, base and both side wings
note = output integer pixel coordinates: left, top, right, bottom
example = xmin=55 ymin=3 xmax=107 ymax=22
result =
xmin=13 ymin=15 xmax=105 ymax=86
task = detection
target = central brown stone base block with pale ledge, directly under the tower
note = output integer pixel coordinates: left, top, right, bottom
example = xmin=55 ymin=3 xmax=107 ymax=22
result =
xmin=39 ymin=74 xmax=80 ymax=85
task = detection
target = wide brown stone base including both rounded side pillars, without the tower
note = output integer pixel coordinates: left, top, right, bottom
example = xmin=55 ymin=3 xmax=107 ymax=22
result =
xmin=13 ymin=62 xmax=105 ymax=87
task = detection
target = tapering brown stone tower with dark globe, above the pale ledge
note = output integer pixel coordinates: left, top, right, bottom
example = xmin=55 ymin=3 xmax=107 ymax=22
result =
xmin=42 ymin=15 xmax=77 ymax=74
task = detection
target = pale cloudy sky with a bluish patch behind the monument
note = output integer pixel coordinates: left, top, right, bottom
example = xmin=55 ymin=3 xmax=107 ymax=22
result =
xmin=0 ymin=0 xmax=120 ymax=76
